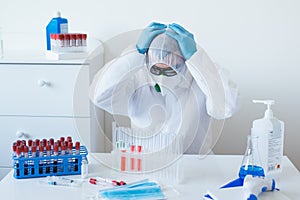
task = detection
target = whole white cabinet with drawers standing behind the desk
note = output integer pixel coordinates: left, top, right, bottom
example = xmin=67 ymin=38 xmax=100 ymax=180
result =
xmin=0 ymin=44 xmax=104 ymax=172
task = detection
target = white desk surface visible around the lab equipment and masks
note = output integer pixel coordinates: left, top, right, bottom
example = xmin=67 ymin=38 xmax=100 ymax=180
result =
xmin=0 ymin=154 xmax=300 ymax=200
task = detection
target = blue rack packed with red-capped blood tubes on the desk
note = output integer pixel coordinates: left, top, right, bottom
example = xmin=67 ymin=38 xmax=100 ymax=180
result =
xmin=12 ymin=136 xmax=88 ymax=179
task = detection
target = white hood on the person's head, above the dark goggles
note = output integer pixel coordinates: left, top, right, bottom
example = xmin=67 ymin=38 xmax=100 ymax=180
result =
xmin=146 ymin=29 xmax=185 ymax=74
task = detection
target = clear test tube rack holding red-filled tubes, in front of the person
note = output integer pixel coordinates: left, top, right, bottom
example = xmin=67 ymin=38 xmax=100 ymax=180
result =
xmin=112 ymin=124 xmax=184 ymax=182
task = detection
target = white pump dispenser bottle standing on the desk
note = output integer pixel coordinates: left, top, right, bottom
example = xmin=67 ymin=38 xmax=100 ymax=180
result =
xmin=251 ymin=100 xmax=284 ymax=175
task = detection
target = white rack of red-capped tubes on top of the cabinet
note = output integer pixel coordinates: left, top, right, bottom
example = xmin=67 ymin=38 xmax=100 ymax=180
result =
xmin=50 ymin=33 xmax=87 ymax=52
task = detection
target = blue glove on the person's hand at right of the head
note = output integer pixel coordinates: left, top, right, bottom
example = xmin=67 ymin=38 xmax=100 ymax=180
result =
xmin=166 ymin=23 xmax=197 ymax=60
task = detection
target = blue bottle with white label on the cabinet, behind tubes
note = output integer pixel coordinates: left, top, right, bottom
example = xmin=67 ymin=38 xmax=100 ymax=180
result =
xmin=46 ymin=12 xmax=68 ymax=50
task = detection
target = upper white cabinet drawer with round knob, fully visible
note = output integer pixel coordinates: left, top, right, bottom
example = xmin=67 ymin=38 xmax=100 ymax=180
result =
xmin=0 ymin=64 xmax=90 ymax=117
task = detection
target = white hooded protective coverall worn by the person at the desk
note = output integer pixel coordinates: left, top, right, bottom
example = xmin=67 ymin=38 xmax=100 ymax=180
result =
xmin=90 ymin=33 xmax=238 ymax=154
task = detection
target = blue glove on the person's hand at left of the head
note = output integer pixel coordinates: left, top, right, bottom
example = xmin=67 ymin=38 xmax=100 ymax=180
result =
xmin=136 ymin=22 xmax=167 ymax=54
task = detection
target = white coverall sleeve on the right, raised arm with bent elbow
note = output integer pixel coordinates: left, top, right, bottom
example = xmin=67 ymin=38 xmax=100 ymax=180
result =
xmin=186 ymin=46 xmax=238 ymax=119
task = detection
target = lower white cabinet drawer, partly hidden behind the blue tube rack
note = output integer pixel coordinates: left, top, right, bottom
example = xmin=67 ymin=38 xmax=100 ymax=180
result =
xmin=0 ymin=116 xmax=90 ymax=167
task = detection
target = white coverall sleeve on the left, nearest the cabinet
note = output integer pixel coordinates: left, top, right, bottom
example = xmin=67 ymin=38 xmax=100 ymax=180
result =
xmin=89 ymin=44 xmax=145 ymax=115
